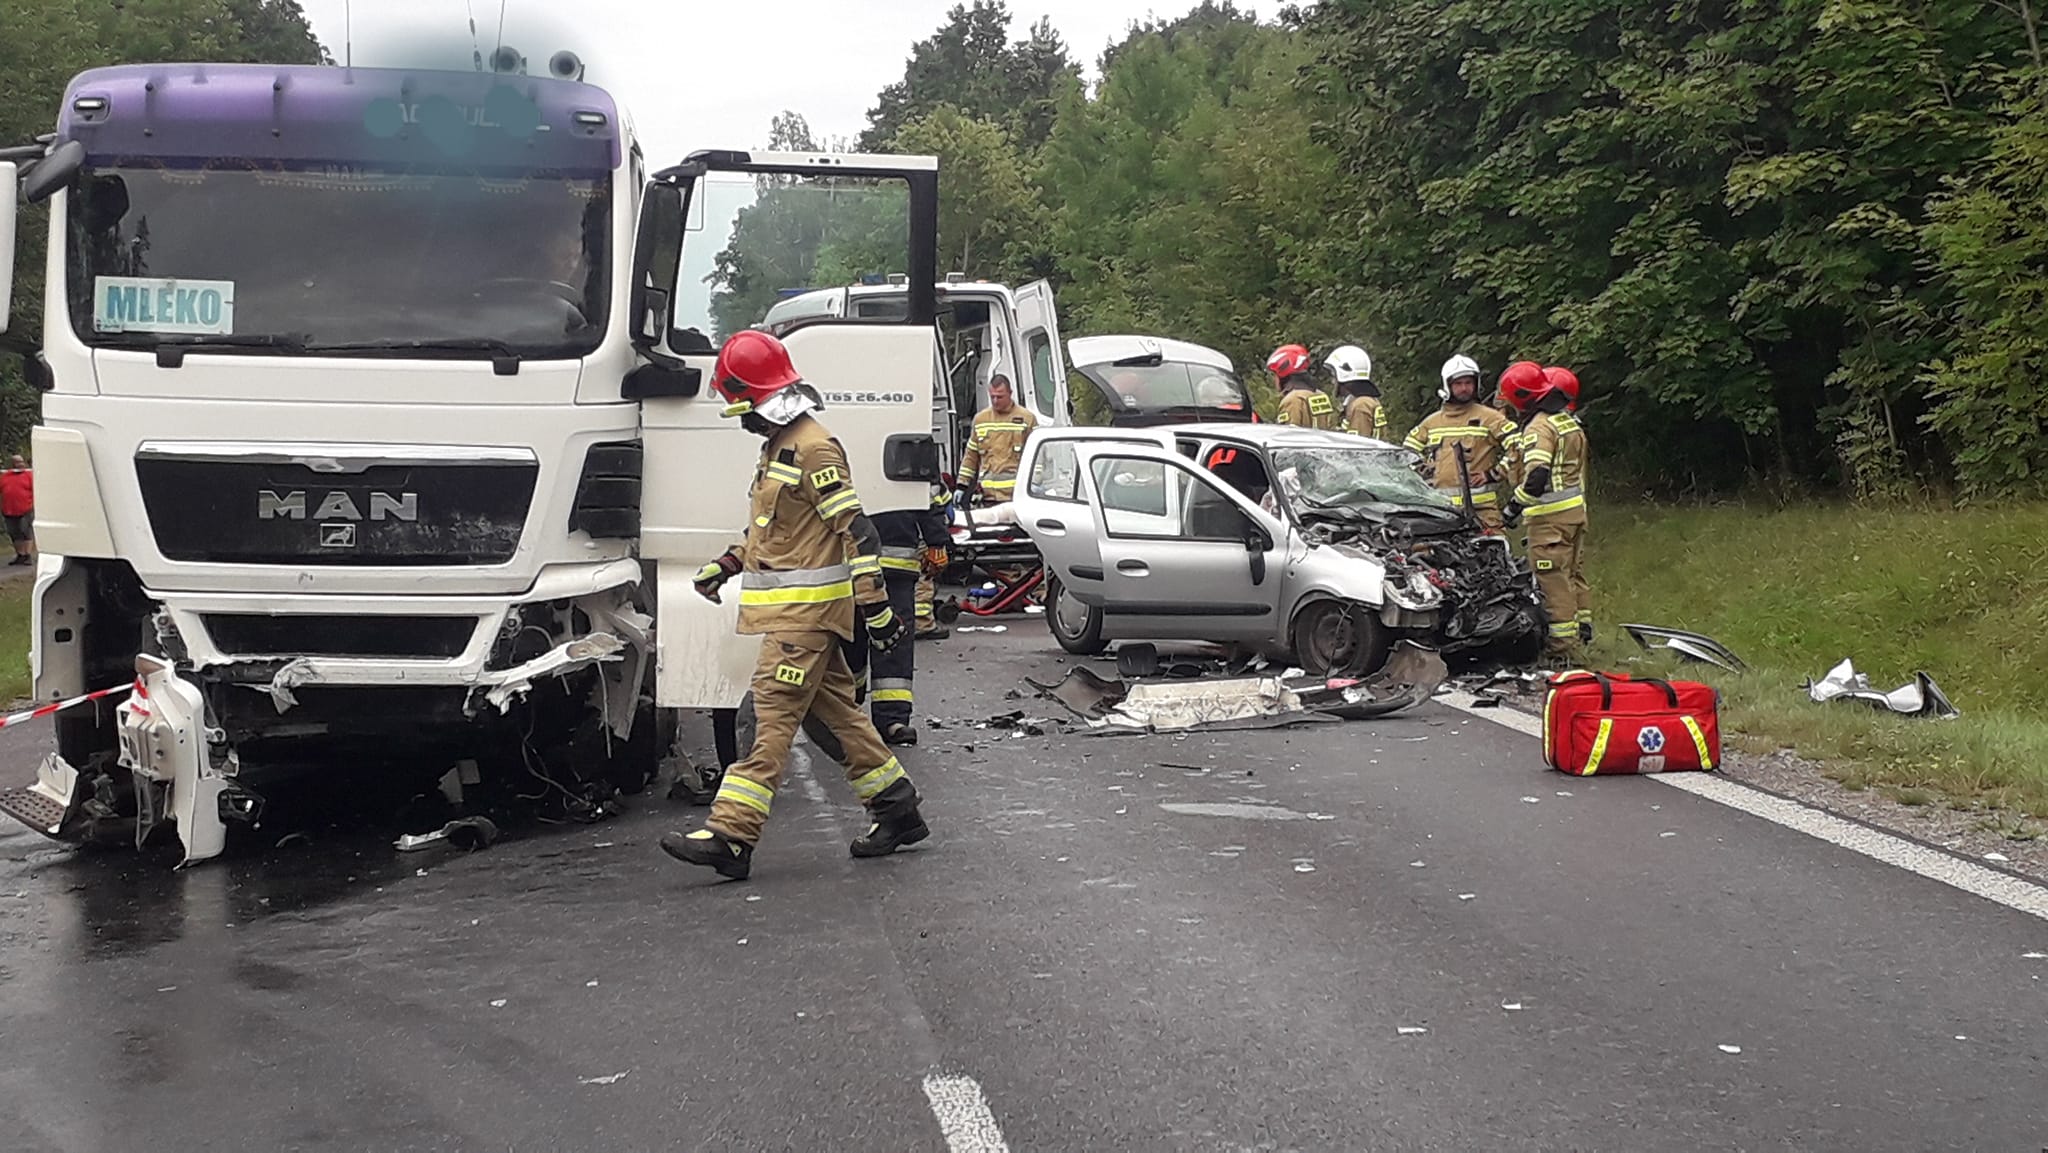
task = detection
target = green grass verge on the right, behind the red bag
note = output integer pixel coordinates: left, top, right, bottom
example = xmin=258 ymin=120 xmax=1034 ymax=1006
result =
xmin=1587 ymin=504 xmax=2048 ymax=819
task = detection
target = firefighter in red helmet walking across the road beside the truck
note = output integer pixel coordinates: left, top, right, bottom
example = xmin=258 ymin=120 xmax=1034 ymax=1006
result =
xmin=662 ymin=330 xmax=930 ymax=881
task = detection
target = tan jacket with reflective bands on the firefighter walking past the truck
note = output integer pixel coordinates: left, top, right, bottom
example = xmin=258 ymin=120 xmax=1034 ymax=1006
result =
xmin=733 ymin=414 xmax=889 ymax=641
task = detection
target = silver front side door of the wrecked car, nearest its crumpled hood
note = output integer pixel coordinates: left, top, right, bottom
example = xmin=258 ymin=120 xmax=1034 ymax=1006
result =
xmin=1077 ymin=440 xmax=1286 ymax=641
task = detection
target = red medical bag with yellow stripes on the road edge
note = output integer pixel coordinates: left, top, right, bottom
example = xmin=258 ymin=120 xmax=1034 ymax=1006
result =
xmin=1542 ymin=672 xmax=1720 ymax=776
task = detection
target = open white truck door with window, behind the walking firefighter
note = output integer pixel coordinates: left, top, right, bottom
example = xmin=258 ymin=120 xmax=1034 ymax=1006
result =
xmin=623 ymin=152 xmax=940 ymax=709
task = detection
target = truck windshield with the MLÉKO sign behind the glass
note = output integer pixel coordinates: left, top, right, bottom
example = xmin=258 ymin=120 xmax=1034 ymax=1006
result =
xmin=66 ymin=164 xmax=610 ymax=358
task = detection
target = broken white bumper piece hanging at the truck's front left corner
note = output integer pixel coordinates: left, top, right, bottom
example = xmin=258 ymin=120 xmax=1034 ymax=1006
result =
xmin=115 ymin=655 xmax=227 ymax=868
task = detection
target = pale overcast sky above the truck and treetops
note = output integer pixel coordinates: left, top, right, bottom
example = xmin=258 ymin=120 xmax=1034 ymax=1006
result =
xmin=301 ymin=0 xmax=1194 ymax=168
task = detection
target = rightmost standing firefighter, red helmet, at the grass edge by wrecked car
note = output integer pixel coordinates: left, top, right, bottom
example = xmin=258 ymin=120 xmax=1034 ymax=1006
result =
xmin=1501 ymin=360 xmax=1593 ymax=659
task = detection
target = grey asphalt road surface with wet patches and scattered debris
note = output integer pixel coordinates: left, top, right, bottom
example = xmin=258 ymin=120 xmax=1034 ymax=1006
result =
xmin=0 ymin=618 xmax=2048 ymax=1151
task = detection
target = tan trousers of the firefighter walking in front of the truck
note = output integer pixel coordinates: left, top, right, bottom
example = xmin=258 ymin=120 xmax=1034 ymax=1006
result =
xmin=705 ymin=633 xmax=905 ymax=844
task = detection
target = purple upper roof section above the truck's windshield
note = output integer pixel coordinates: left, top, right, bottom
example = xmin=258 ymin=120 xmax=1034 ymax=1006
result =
xmin=57 ymin=63 xmax=621 ymax=172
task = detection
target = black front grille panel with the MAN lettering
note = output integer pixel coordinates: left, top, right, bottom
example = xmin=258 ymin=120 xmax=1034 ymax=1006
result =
xmin=135 ymin=453 xmax=541 ymax=565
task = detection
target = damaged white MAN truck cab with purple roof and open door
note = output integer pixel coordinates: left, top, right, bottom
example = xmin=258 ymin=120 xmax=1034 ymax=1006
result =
xmin=0 ymin=63 xmax=936 ymax=860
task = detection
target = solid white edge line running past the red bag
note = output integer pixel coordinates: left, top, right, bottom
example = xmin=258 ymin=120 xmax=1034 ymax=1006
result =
xmin=1438 ymin=692 xmax=2048 ymax=922
